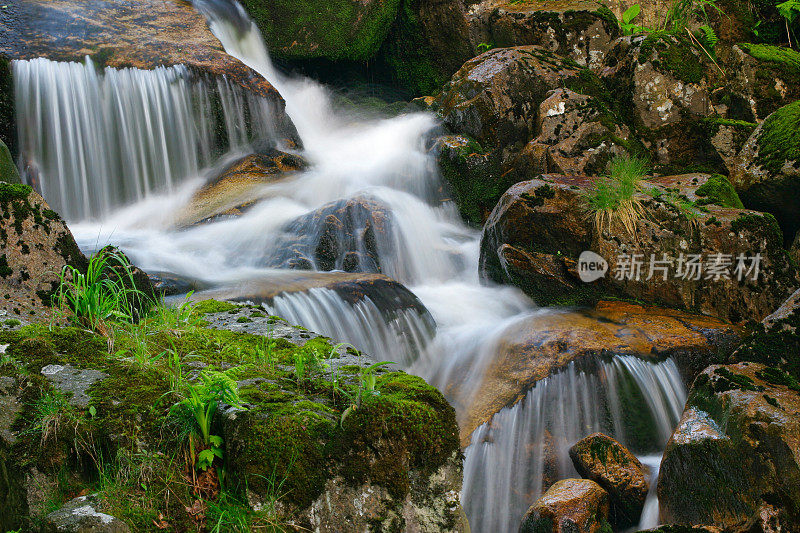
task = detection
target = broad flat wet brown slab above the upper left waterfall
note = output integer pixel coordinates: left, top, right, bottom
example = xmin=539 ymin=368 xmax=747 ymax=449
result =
xmin=0 ymin=0 xmax=297 ymax=129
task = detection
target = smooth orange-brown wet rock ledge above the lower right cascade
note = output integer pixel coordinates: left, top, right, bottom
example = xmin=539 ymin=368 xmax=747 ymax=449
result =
xmin=456 ymin=302 xmax=740 ymax=445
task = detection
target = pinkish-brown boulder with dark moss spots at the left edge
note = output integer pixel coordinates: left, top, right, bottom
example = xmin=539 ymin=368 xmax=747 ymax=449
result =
xmin=0 ymin=183 xmax=87 ymax=322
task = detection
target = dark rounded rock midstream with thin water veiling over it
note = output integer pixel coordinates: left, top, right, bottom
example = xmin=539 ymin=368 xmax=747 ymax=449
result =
xmin=267 ymin=196 xmax=393 ymax=273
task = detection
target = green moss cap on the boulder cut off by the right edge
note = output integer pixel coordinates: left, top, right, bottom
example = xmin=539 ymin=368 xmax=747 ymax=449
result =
xmin=756 ymin=101 xmax=800 ymax=174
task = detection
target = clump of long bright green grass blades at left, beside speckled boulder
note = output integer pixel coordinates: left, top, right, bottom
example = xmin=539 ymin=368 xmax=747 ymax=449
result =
xmin=56 ymin=253 xmax=147 ymax=331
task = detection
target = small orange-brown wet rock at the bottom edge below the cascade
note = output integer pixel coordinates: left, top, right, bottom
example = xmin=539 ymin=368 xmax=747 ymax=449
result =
xmin=519 ymin=479 xmax=609 ymax=533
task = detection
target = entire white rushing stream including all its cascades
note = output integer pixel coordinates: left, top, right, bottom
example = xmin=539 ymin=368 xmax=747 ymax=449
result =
xmin=14 ymin=0 xmax=685 ymax=533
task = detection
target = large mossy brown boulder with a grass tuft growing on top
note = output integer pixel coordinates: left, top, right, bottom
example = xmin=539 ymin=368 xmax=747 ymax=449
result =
xmin=480 ymin=174 xmax=798 ymax=322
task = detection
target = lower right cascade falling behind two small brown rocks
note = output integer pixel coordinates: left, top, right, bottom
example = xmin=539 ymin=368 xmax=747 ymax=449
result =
xmin=461 ymin=356 xmax=686 ymax=533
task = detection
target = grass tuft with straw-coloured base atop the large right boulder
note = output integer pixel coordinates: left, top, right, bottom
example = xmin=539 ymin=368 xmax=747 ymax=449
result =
xmin=584 ymin=156 xmax=649 ymax=235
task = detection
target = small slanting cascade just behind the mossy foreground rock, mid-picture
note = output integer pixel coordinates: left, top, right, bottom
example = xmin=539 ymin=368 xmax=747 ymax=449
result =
xmin=264 ymin=287 xmax=435 ymax=367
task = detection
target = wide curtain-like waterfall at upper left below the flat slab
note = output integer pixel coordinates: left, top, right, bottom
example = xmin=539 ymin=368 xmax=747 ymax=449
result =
xmin=13 ymin=57 xmax=282 ymax=220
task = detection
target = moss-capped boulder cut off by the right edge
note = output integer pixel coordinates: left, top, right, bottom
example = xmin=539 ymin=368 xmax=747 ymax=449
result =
xmin=731 ymin=102 xmax=800 ymax=246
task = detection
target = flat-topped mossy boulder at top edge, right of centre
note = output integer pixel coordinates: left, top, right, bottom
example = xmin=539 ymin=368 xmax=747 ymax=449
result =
xmin=467 ymin=0 xmax=621 ymax=68
